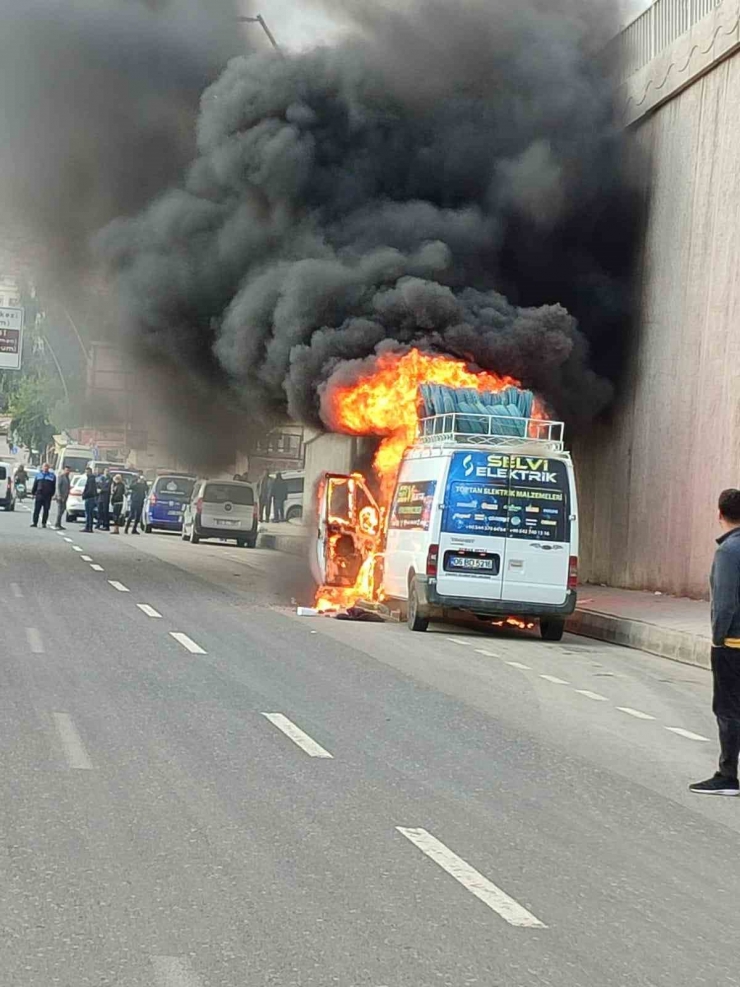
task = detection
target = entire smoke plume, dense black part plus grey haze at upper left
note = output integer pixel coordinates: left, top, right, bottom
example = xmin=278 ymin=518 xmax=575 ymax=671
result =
xmin=0 ymin=0 xmax=641 ymax=452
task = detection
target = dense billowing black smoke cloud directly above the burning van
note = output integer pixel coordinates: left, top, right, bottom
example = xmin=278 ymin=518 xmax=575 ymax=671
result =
xmin=98 ymin=0 xmax=641 ymax=436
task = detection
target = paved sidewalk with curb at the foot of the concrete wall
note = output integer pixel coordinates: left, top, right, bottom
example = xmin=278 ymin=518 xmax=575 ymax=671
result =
xmin=567 ymin=586 xmax=711 ymax=668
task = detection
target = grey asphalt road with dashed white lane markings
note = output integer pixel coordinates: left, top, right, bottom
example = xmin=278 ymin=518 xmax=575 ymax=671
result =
xmin=0 ymin=511 xmax=740 ymax=987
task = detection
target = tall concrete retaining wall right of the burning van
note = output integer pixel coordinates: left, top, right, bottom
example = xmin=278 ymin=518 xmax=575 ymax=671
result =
xmin=574 ymin=46 xmax=740 ymax=597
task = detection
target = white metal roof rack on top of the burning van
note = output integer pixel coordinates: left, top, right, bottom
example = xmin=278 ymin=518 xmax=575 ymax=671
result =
xmin=415 ymin=412 xmax=565 ymax=451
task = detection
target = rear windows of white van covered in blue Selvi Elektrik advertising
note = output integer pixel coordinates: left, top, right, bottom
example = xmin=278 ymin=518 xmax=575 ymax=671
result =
xmin=442 ymin=452 xmax=570 ymax=542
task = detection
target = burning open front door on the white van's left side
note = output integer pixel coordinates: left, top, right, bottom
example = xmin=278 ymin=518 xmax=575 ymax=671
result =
xmin=313 ymin=473 xmax=381 ymax=587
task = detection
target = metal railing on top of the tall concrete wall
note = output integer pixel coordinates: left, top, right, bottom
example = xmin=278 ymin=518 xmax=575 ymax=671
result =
xmin=610 ymin=0 xmax=725 ymax=78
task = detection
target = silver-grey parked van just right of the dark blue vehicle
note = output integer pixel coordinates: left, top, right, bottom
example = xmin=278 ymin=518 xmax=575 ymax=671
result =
xmin=182 ymin=480 xmax=258 ymax=548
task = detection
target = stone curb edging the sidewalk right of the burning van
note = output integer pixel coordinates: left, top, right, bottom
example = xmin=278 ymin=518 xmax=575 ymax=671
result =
xmin=565 ymin=608 xmax=712 ymax=668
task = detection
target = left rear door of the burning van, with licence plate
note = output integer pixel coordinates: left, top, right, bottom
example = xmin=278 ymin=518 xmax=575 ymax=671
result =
xmin=437 ymin=451 xmax=509 ymax=600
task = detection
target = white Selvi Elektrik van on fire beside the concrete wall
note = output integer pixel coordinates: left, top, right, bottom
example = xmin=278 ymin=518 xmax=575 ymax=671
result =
xmin=318 ymin=415 xmax=578 ymax=641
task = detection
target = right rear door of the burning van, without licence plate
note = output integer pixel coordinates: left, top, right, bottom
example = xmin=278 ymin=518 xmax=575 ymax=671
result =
xmin=501 ymin=456 xmax=575 ymax=605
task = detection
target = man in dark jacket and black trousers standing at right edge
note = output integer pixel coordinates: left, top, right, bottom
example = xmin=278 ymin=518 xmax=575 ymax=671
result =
xmin=689 ymin=489 xmax=740 ymax=795
